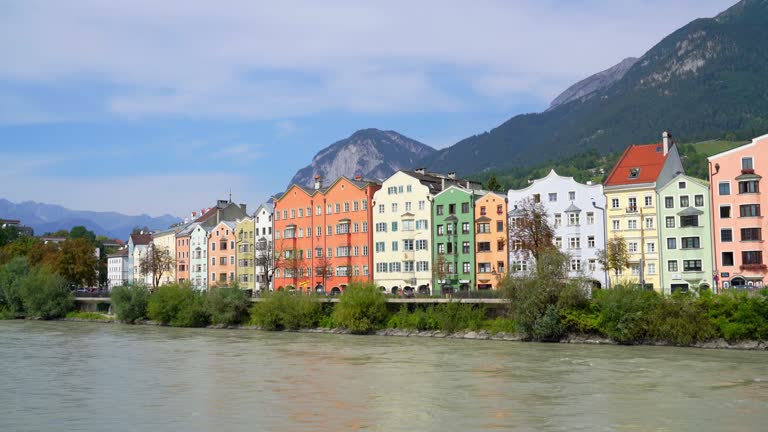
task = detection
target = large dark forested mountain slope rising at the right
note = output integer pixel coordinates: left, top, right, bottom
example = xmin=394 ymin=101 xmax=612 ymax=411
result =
xmin=419 ymin=0 xmax=768 ymax=175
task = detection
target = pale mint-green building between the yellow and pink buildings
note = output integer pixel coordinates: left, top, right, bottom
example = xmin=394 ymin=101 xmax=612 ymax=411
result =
xmin=658 ymin=174 xmax=713 ymax=294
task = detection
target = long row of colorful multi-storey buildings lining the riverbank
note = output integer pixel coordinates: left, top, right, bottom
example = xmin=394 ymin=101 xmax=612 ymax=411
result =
xmin=110 ymin=132 xmax=768 ymax=294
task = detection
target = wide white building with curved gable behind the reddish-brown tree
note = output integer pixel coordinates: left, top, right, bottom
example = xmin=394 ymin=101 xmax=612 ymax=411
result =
xmin=507 ymin=170 xmax=607 ymax=287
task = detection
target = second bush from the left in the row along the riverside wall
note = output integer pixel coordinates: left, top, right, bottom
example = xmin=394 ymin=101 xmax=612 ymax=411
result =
xmin=147 ymin=284 xmax=210 ymax=327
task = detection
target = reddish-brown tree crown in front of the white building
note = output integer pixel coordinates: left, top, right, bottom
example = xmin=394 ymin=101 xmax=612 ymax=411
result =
xmin=509 ymin=198 xmax=555 ymax=262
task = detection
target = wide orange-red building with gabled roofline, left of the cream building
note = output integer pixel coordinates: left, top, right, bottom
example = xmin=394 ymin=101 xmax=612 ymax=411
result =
xmin=273 ymin=176 xmax=381 ymax=293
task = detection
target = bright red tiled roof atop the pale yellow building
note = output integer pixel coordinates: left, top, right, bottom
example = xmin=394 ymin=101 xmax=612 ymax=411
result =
xmin=604 ymin=143 xmax=669 ymax=186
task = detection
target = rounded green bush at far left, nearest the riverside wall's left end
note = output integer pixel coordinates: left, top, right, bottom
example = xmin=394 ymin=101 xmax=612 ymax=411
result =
xmin=19 ymin=267 xmax=75 ymax=319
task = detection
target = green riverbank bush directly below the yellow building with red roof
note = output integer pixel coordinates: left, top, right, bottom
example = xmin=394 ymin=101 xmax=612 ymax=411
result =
xmin=596 ymin=288 xmax=661 ymax=344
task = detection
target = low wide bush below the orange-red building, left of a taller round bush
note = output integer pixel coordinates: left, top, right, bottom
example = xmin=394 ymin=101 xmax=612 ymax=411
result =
xmin=251 ymin=291 xmax=331 ymax=330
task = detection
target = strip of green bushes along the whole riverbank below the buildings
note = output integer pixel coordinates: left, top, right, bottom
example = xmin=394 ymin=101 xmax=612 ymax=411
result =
xmin=0 ymin=253 xmax=768 ymax=349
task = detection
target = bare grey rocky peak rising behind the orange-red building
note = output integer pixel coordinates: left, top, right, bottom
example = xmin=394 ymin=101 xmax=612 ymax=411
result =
xmin=291 ymin=129 xmax=436 ymax=186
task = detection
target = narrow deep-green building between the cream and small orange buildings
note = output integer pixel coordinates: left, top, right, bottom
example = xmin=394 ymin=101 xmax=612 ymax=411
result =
xmin=432 ymin=186 xmax=477 ymax=294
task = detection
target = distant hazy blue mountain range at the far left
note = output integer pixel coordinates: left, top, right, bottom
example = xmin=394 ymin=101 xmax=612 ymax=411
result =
xmin=0 ymin=199 xmax=181 ymax=239
